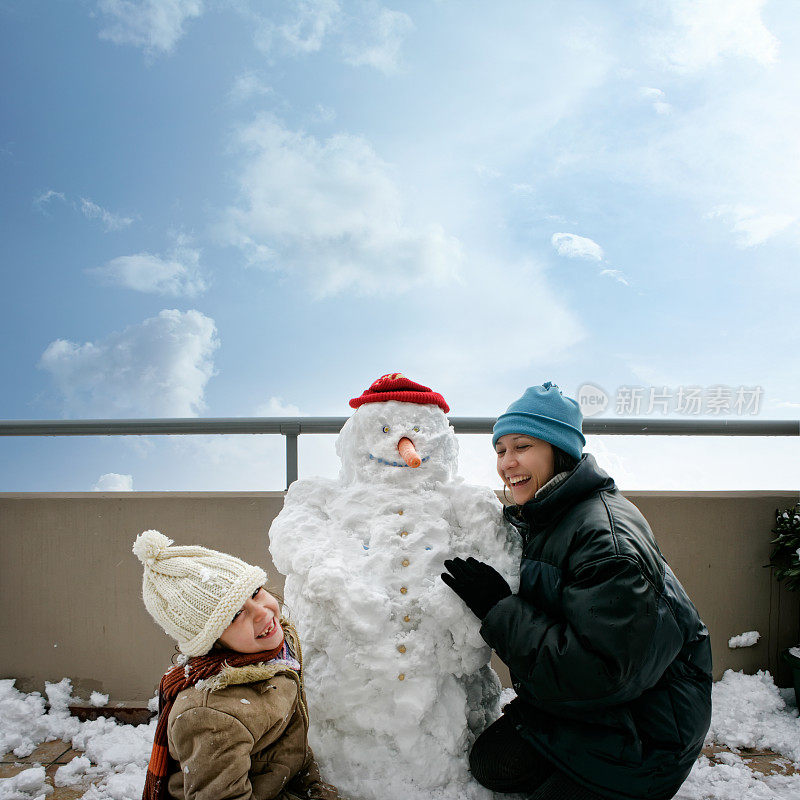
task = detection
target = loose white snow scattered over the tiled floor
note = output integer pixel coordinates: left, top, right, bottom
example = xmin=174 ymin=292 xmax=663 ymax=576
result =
xmin=0 ymin=670 xmax=800 ymax=800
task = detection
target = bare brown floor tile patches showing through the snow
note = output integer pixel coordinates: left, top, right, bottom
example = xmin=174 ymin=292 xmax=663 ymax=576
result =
xmin=0 ymin=742 xmax=800 ymax=800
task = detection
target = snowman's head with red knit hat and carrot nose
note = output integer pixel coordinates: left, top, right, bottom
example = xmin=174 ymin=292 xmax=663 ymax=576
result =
xmin=336 ymin=373 xmax=458 ymax=487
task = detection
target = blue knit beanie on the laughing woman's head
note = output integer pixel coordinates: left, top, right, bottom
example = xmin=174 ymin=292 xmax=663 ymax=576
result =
xmin=492 ymin=381 xmax=586 ymax=461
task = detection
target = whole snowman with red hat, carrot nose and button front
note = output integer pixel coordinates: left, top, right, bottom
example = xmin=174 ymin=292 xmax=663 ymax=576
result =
xmin=269 ymin=373 xmax=520 ymax=800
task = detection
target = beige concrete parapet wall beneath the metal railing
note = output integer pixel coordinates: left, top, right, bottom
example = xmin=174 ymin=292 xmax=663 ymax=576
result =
xmin=0 ymin=491 xmax=800 ymax=702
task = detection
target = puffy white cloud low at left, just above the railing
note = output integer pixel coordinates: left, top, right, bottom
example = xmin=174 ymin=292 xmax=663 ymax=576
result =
xmin=39 ymin=309 xmax=219 ymax=417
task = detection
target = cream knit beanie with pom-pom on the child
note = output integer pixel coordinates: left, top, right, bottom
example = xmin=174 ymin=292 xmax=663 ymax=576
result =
xmin=133 ymin=531 xmax=267 ymax=656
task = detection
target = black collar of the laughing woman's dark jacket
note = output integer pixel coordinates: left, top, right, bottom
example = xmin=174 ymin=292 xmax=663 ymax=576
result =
xmin=503 ymin=453 xmax=615 ymax=528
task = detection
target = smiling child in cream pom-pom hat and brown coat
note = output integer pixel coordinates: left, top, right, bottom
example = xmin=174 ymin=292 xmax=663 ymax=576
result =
xmin=133 ymin=531 xmax=338 ymax=800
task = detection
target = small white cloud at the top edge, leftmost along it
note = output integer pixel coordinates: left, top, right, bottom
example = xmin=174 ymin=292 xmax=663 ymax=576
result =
xmin=98 ymin=0 xmax=203 ymax=54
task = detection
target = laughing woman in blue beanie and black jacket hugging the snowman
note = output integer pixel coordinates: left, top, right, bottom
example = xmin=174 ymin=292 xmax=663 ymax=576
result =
xmin=442 ymin=382 xmax=711 ymax=800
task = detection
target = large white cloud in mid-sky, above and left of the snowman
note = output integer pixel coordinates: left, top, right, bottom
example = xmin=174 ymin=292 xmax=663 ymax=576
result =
xmin=221 ymin=117 xmax=461 ymax=296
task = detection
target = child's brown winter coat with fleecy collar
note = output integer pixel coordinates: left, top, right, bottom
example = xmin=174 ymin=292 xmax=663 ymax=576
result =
xmin=167 ymin=664 xmax=338 ymax=800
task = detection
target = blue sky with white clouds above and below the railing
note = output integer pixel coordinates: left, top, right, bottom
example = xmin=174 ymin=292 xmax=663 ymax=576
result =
xmin=0 ymin=0 xmax=800 ymax=491
